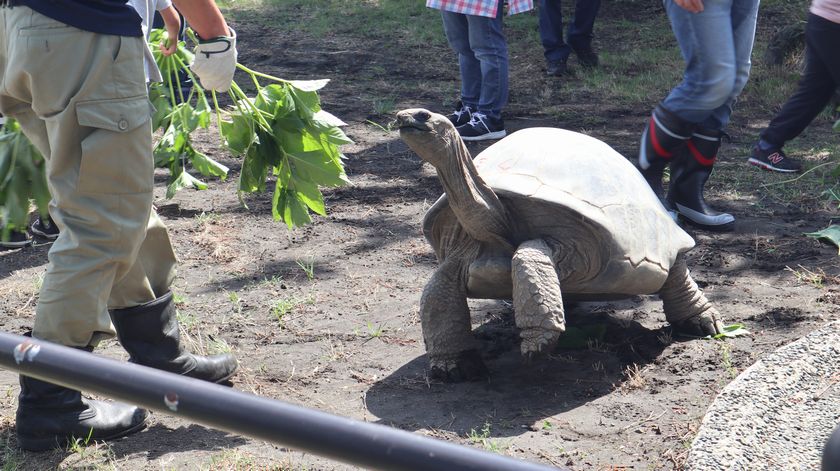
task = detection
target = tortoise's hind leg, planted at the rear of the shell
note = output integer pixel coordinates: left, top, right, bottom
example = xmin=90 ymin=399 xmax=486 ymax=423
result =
xmin=659 ymin=254 xmax=723 ymax=335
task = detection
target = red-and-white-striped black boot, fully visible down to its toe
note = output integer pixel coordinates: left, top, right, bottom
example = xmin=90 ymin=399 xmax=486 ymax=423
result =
xmin=667 ymin=129 xmax=735 ymax=232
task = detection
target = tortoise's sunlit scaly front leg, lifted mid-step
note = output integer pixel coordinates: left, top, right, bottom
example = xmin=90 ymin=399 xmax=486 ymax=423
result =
xmin=512 ymin=239 xmax=566 ymax=359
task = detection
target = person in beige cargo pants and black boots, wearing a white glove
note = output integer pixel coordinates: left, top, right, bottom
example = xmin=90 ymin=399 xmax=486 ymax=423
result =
xmin=0 ymin=0 xmax=237 ymax=450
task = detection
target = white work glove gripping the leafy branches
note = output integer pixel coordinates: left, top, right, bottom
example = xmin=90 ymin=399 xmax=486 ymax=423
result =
xmin=190 ymin=28 xmax=236 ymax=92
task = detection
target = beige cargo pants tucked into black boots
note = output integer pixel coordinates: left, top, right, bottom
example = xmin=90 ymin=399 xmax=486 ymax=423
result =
xmin=0 ymin=6 xmax=175 ymax=347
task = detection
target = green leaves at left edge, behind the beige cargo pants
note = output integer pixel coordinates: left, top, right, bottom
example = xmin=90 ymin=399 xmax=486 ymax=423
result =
xmin=0 ymin=118 xmax=50 ymax=239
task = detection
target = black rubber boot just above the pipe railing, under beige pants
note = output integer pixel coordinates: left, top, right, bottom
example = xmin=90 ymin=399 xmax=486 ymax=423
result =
xmin=110 ymin=292 xmax=238 ymax=383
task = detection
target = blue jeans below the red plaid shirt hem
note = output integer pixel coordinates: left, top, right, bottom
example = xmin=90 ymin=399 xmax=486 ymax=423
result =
xmin=441 ymin=5 xmax=508 ymax=118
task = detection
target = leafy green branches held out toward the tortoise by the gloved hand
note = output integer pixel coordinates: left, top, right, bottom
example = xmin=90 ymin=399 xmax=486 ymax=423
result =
xmin=149 ymin=30 xmax=352 ymax=227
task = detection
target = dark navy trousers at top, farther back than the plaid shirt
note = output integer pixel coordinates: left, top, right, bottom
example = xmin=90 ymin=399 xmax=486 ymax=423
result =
xmin=539 ymin=0 xmax=601 ymax=62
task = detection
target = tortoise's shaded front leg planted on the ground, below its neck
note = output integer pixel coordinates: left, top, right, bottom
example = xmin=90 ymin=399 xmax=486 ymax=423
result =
xmin=420 ymin=259 xmax=487 ymax=382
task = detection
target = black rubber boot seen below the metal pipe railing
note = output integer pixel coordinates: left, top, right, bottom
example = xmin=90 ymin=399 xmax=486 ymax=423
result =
xmin=15 ymin=348 xmax=148 ymax=451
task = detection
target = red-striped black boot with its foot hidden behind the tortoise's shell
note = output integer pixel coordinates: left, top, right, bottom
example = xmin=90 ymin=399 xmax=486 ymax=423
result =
xmin=639 ymin=104 xmax=695 ymax=199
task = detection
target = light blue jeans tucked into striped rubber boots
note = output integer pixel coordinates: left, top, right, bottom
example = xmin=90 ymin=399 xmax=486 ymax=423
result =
xmin=662 ymin=0 xmax=759 ymax=130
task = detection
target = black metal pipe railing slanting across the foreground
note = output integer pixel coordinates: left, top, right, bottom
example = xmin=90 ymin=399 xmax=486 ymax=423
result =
xmin=0 ymin=332 xmax=557 ymax=471
